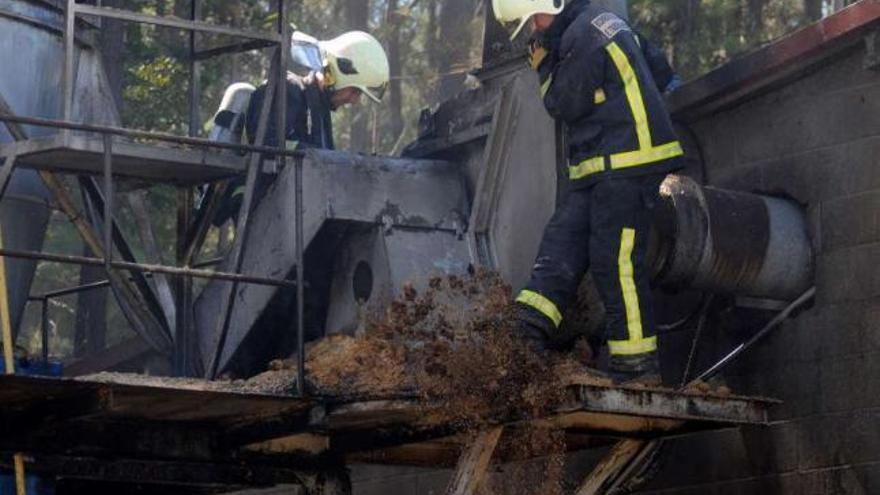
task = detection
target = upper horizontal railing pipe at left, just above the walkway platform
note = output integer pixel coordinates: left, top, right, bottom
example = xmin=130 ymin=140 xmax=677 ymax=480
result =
xmin=0 ymin=112 xmax=304 ymax=157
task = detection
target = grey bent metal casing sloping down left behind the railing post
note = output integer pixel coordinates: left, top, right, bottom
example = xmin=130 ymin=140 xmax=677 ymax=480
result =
xmin=195 ymin=150 xmax=468 ymax=376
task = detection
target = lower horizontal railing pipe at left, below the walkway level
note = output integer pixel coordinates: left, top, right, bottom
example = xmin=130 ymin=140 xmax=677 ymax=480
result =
xmin=0 ymin=249 xmax=296 ymax=287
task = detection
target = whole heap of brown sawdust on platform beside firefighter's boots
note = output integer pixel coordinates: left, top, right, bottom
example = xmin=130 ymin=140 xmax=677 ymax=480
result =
xmin=248 ymin=271 xmax=610 ymax=414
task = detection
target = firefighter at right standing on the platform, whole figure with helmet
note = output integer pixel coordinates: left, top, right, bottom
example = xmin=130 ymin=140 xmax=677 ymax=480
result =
xmin=493 ymin=0 xmax=683 ymax=382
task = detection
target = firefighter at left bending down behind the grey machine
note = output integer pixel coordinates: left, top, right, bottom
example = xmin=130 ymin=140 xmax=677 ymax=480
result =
xmin=214 ymin=31 xmax=390 ymax=225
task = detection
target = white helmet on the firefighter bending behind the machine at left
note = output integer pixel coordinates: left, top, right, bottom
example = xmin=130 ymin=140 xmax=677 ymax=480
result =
xmin=318 ymin=31 xmax=391 ymax=103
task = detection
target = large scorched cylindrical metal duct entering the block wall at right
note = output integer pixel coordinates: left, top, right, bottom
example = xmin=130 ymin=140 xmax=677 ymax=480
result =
xmin=651 ymin=175 xmax=814 ymax=300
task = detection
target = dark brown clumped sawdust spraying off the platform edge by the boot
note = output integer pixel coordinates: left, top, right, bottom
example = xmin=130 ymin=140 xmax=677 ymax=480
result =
xmin=369 ymin=272 xmax=563 ymax=428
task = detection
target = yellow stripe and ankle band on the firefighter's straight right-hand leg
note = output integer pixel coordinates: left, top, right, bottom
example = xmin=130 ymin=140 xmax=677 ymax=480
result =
xmin=608 ymin=228 xmax=657 ymax=354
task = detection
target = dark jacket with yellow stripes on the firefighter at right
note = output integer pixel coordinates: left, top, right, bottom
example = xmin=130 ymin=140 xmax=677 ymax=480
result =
xmin=537 ymin=0 xmax=683 ymax=187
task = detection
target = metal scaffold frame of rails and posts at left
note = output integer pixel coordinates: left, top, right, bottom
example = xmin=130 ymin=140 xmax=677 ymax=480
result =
xmin=0 ymin=0 xmax=305 ymax=394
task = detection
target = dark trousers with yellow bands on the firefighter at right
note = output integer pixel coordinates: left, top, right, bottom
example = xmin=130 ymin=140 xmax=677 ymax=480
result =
xmin=516 ymin=174 xmax=664 ymax=357
